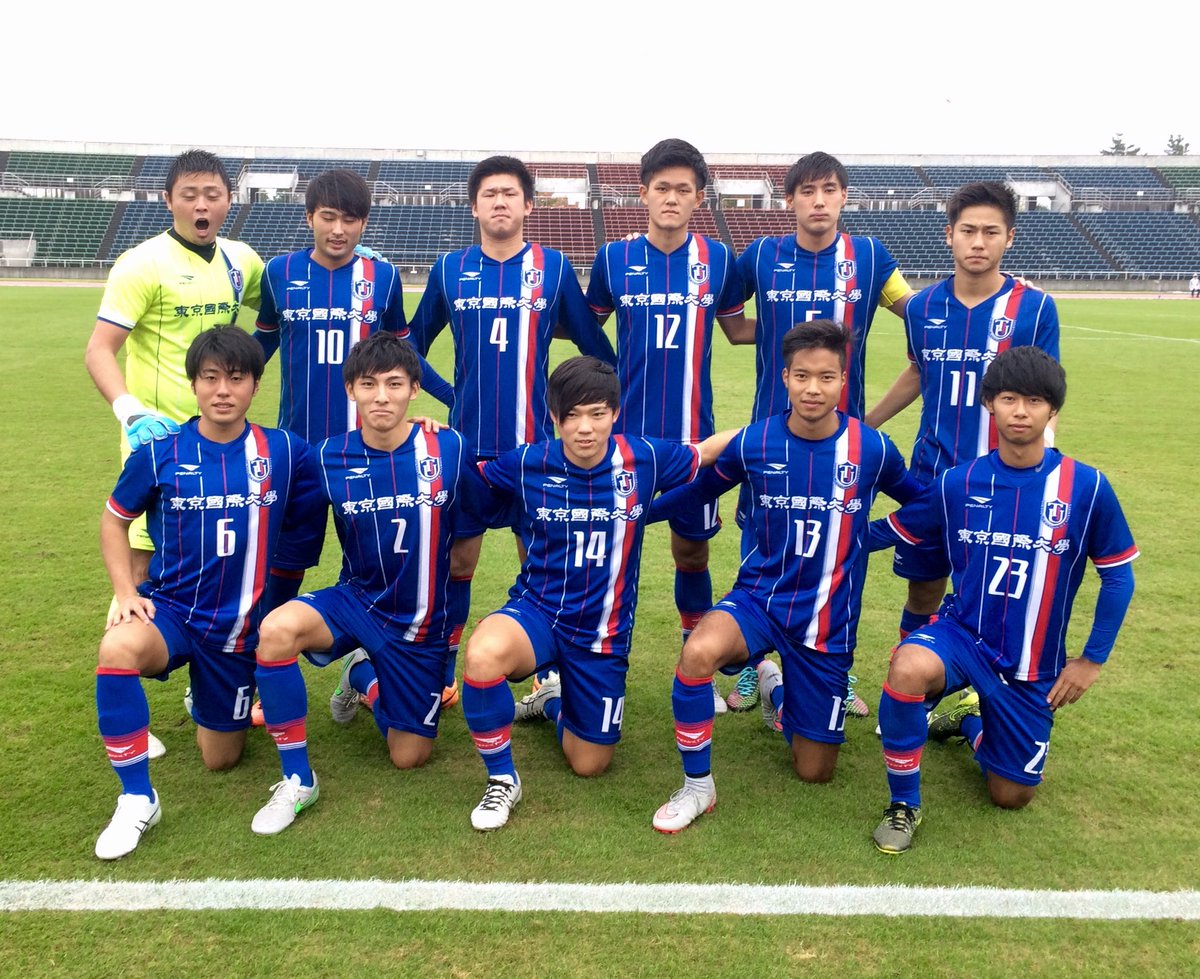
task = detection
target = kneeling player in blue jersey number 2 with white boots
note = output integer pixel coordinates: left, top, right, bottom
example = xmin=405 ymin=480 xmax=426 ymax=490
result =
xmin=251 ymin=332 xmax=479 ymax=835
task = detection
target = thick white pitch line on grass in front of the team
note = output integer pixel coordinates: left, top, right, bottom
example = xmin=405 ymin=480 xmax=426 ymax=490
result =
xmin=0 ymin=879 xmax=1200 ymax=921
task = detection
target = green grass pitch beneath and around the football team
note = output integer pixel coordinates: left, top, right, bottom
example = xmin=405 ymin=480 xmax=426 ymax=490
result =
xmin=0 ymin=287 xmax=1200 ymax=977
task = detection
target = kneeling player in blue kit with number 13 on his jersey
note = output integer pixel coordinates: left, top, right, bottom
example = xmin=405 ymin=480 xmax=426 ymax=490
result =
xmin=652 ymin=320 xmax=919 ymax=833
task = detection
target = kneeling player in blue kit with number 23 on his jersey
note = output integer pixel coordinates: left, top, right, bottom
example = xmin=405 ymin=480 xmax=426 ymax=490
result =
xmin=871 ymin=347 xmax=1138 ymax=853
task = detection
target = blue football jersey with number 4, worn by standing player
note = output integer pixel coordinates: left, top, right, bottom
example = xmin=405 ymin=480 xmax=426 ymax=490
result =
xmin=409 ymin=242 xmax=617 ymax=458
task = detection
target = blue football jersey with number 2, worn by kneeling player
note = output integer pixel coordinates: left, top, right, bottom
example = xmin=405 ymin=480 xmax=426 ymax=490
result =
xmin=317 ymin=425 xmax=479 ymax=644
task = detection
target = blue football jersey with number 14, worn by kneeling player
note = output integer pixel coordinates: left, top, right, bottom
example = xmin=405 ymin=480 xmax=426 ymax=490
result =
xmin=479 ymin=436 xmax=700 ymax=655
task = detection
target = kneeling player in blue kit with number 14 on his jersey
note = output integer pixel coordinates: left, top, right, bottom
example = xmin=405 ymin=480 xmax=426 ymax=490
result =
xmin=462 ymin=356 xmax=732 ymax=830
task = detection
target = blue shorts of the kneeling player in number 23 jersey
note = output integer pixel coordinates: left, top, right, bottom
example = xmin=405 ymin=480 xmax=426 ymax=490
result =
xmin=902 ymin=618 xmax=1057 ymax=786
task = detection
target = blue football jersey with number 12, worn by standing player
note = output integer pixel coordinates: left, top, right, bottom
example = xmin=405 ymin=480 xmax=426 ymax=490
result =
xmin=587 ymin=235 xmax=745 ymax=443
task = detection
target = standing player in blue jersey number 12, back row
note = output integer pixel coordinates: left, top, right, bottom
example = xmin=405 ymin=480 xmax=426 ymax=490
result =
xmin=588 ymin=139 xmax=754 ymax=711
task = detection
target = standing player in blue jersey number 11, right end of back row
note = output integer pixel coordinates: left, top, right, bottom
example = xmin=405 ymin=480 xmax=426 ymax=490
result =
xmin=866 ymin=181 xmax=1058 ymax=638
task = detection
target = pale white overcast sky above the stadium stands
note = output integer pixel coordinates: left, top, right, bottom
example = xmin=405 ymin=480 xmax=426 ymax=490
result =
xmin=7 ymin=0 xmax=1200 ymax=156
